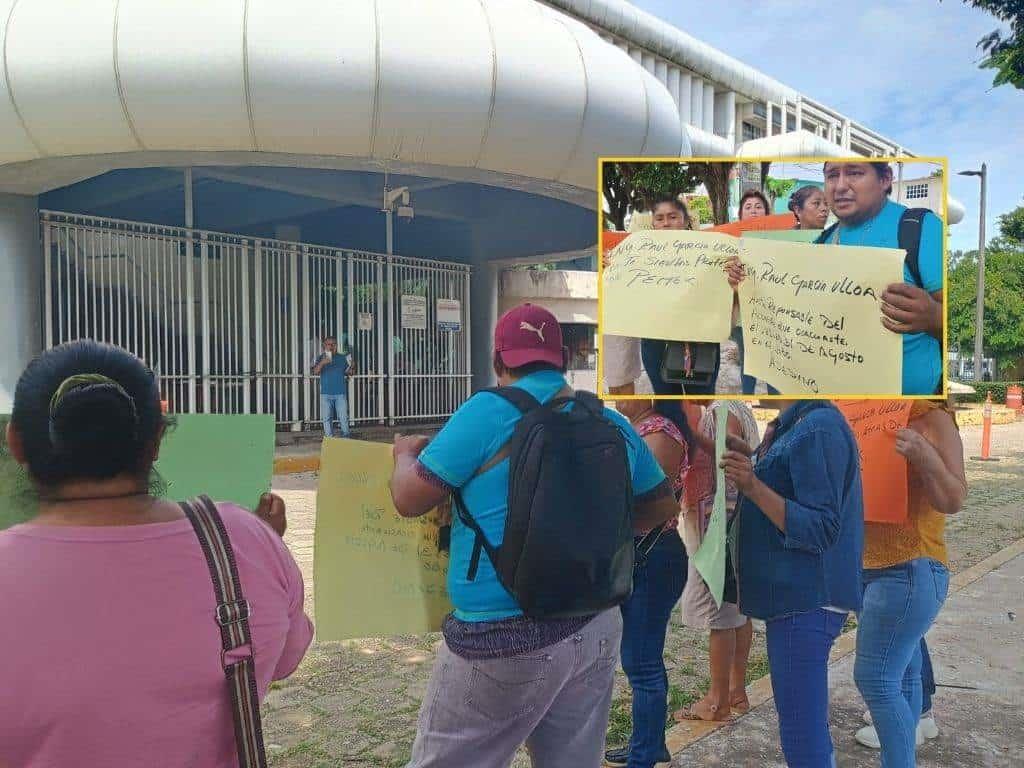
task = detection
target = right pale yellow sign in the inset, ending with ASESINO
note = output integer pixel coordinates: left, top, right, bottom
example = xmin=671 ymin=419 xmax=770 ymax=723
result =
xmin=739 ymin=239 xmax=904 ymax=396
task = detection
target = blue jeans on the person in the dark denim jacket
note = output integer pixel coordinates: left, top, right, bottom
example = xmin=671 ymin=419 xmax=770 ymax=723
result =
xmin=765 ymin=608 xmax=847 ymax=768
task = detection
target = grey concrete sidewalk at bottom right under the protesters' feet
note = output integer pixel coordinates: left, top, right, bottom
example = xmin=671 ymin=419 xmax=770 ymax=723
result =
xmin=672 ymin=554 xmax=1024 ymax=768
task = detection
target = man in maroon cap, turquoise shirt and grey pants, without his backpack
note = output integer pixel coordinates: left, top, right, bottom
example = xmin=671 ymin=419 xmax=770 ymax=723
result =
xmin=391 ymin=304 xmax=679 ymax=768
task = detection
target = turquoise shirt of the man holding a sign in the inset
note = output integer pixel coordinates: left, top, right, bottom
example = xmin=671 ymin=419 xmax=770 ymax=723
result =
xmin=828 ymin=200 xmax=943 ymax=394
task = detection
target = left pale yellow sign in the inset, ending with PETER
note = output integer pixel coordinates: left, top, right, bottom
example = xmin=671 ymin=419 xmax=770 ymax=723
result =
xmin=600 ymin=229 xmax=739 ymax=341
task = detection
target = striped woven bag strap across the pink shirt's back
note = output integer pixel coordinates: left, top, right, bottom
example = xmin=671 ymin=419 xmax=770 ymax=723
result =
xmin=179 ymin=496 xmax=267 ymax=768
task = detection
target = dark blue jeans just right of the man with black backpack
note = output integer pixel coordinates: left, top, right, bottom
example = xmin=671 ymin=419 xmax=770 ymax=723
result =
xmin=622 ymin=530 xmax=687 ymax=768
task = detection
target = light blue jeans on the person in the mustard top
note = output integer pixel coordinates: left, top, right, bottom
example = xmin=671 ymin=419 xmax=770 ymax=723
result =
xmin=853 ymin=557 xmax=949 ymax=768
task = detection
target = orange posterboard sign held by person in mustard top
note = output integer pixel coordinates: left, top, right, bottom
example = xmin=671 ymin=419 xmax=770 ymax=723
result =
xmin=836 ymin=400 xmax=913 ymax=523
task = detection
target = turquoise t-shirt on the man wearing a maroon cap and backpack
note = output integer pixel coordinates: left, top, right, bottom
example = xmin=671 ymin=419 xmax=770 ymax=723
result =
xmin=420 ymin=371 xmax=665 ymax=622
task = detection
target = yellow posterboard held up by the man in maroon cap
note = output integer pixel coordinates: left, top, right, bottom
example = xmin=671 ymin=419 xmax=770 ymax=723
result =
xmin=313 ymin=438 xmax=452 ymax=640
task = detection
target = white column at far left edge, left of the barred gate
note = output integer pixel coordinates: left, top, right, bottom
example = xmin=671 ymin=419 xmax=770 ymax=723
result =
xmin=0 ymin=195 xmax=41 ymax=414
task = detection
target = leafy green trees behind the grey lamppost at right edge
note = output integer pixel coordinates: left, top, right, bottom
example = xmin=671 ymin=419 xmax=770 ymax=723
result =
xmin=948 ymin=207 xmax=1024 ymax=370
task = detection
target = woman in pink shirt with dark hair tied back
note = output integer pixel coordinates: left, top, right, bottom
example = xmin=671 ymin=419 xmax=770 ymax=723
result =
xmin=0 ymin=341 xmax=312 ymax=768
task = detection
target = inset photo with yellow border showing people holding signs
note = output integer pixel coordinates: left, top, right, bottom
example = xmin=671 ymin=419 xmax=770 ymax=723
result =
xmin=598 ymin=157 xmax=959 ymax=399
